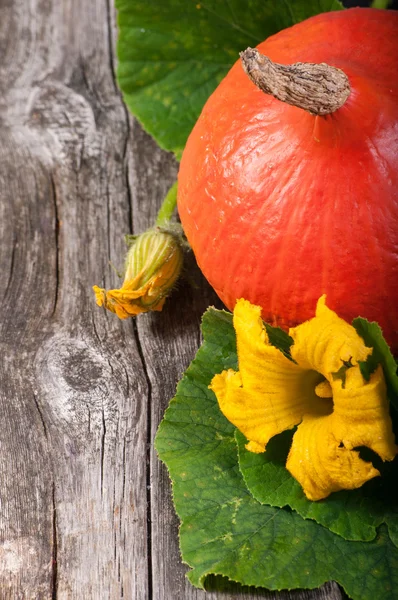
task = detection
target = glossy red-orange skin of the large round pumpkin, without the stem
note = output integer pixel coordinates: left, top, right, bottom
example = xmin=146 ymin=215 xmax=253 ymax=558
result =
xmin=178 ymin=8 xmax=398 ymax=352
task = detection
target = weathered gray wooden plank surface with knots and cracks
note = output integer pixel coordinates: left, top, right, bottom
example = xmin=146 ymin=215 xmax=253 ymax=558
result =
xmin=0 ymin=0 xmax=342 ymax=600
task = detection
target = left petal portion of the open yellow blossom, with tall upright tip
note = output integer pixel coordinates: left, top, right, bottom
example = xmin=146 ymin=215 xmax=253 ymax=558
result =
xmin=210 ymin=300 xmax=330 ymax=452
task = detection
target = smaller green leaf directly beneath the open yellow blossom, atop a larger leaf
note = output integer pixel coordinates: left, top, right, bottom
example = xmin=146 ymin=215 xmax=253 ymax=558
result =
xmin=235 ymin=431 xmax=398 ymax=546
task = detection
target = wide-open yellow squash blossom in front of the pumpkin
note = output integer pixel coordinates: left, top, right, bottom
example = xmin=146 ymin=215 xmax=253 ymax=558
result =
xmin=210 ymin=296 xmax=398 ymax=500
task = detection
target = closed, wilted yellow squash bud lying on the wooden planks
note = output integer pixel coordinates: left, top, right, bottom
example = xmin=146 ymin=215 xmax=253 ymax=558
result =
xmin=93 ymin=227 xmax=183 ymax=319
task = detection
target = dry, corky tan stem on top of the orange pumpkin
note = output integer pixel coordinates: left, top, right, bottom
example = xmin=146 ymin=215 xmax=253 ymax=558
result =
xmin=240 ymin=48 xmax=351 ymax=116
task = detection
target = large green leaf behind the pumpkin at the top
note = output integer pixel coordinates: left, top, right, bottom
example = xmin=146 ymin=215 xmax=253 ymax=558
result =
xmin=116 ymin=0 xmax=342 ymax=157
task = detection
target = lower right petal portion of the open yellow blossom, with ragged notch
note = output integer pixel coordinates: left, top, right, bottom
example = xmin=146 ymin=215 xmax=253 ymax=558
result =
xmin=286 ymin=366 xmax=397 ymax=500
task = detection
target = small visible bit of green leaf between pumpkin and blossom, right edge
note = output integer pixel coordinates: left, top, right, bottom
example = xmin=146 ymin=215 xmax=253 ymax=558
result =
xmin=352 ymin=317 xmax=398 ymax=410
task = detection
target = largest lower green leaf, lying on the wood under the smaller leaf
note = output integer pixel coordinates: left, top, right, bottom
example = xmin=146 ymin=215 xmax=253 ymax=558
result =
xmin=156 ymin=310 xmax=398 ymax=600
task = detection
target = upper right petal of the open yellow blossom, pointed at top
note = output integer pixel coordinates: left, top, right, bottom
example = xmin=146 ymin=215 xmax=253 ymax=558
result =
xmin=289 ymin=296 xmax=372 ymax=380
